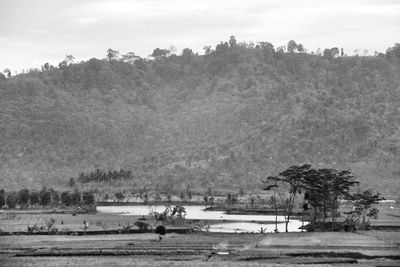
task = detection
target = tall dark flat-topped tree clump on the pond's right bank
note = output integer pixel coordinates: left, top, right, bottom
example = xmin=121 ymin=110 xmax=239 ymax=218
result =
xmin=264 ymin=164 xmax=382 ymax=232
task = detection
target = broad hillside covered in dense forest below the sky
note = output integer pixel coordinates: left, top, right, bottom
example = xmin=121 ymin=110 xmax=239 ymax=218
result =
xmin=0 ymin=38 xmax=400 ymax=196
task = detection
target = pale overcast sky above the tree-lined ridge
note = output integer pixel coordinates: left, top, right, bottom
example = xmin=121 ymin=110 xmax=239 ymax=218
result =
xmin=0 ymin=0 xmax=400 ymax=72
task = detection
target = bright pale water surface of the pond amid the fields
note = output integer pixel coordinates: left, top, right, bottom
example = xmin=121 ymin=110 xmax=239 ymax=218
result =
xmin=97 ymin=205 xmax=301 ymax=233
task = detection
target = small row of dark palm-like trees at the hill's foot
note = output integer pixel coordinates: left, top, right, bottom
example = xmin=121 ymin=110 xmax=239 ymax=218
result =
xmin=77 ymin=169 xmax=133 ymax=184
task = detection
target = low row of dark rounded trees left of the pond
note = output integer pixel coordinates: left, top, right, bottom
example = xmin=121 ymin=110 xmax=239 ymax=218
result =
xmin=0 ymin=187 xmax=95 ymax=208
